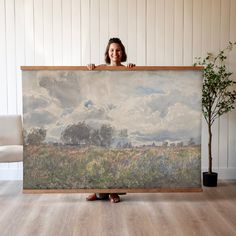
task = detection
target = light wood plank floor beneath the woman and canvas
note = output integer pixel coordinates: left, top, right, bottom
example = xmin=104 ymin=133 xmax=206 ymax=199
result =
xmin=0 ymin=181 xmax=236 ymax=236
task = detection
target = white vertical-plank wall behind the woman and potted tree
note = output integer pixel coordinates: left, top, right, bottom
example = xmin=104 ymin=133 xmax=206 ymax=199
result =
xmin=0 ymin=0 xmax=236 ymax=179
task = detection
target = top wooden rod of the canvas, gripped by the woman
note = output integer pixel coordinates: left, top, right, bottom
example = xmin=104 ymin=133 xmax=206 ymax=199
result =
xmin=21 ymin=65 xmax=203 ymax=71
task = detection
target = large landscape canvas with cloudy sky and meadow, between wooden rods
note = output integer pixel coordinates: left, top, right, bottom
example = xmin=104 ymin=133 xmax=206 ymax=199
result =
xmin=23 ymin=67 xmax=202 ymax=191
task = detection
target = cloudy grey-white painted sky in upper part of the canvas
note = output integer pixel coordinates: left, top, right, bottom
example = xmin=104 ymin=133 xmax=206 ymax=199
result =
xmin=23 ymin=71 xmax=202 ymax=145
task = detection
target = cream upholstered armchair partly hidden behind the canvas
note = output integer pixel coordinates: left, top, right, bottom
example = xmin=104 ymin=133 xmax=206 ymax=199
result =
xmin=0 ymin=115 xmax=23 ymax=162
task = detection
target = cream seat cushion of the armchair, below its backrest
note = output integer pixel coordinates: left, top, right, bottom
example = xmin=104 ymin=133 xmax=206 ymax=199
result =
xmin=0 ymin=145 xmax=23 ymax=162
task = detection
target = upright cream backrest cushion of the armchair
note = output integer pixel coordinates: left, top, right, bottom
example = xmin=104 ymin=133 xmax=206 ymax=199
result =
xmin=0 ymin=115 xmax=23 ymax=145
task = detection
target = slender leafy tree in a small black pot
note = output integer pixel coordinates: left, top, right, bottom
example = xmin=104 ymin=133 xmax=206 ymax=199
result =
xmin=195 ymin=42 xmax=236 ymax=187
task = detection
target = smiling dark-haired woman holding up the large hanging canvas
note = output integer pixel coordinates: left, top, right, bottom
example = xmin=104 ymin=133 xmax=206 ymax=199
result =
xmin=86 ymin=38 xmax=135 ymax=203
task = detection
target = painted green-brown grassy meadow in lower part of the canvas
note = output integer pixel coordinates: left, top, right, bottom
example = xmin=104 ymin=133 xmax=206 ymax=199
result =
xmin=23 ymin=144 xmax=201 ymax=189
